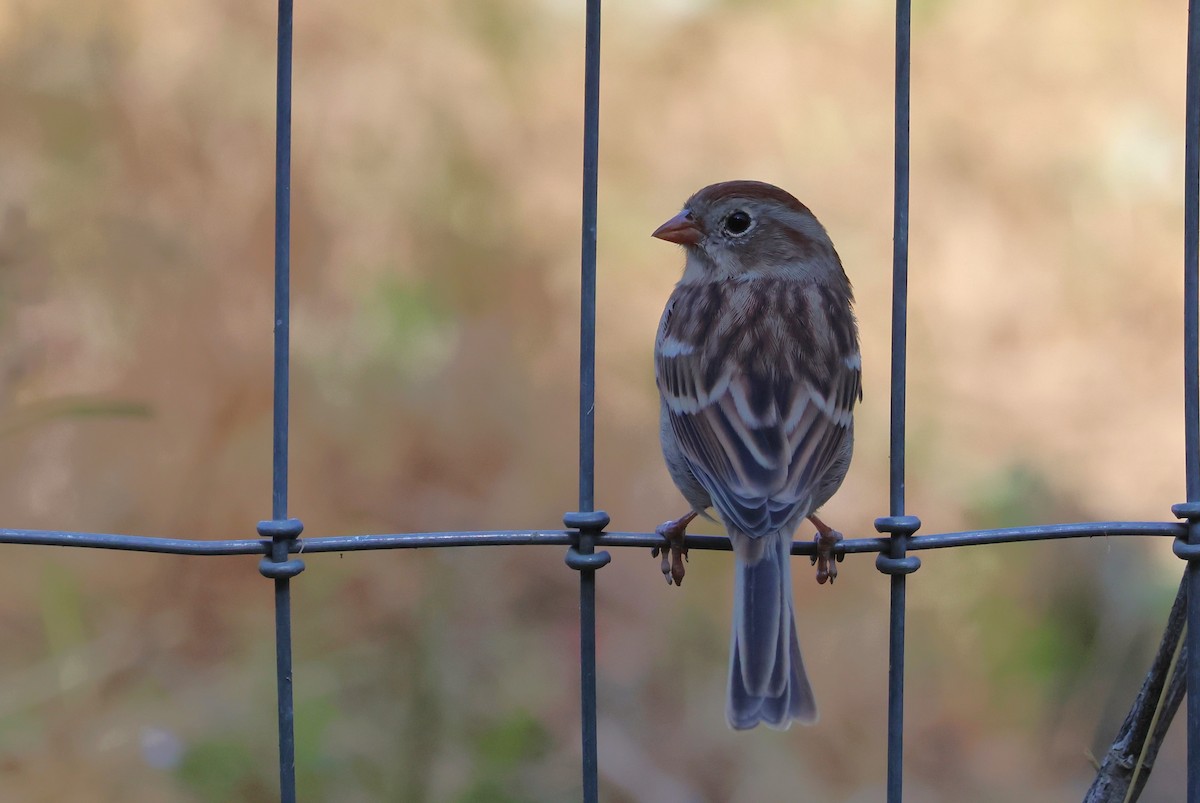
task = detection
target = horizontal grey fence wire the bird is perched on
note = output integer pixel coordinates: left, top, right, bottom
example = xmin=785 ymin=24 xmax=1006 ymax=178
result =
xmin=0 ymin=521 xmax=1187 ymax=556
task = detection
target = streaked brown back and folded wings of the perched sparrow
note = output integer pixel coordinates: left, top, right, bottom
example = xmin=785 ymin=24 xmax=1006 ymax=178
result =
xmin=655 ymin=277 xmax=862 ymax=537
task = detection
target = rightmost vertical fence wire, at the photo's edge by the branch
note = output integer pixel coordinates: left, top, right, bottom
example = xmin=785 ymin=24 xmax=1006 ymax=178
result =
xmin=1183 ymin=0 xmax=1200 ymax=803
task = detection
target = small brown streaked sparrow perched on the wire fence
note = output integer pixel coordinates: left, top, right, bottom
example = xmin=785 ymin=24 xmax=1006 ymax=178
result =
xmin=653 ymin=180 xmax=862 ymax=730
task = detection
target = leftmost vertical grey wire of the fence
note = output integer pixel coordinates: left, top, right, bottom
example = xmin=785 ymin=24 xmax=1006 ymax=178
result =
xmin=271 ymin=0 xmax=296 ymax=803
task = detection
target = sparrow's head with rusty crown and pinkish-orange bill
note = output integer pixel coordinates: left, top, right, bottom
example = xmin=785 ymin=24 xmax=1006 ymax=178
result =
xmin=653 ymin=181 xmax=846 ymax=283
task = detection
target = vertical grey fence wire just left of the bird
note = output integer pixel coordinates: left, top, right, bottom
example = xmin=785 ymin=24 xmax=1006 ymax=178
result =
xmin=578 ymin=0 xmax=600 ymax=803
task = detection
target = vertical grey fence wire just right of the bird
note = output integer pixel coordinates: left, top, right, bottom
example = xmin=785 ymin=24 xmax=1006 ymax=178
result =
xmin=887 ymin=0 xmax=912 ymax=803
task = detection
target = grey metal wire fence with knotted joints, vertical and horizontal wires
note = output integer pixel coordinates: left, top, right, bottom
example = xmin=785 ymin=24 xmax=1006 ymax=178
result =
xmin=9 ymin=0 xmax=1200 ymax=803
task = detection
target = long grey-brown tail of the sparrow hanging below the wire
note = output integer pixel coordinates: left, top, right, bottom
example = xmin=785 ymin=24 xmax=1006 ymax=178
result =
xmin=725 ymin=533 xmax=817 ymax=730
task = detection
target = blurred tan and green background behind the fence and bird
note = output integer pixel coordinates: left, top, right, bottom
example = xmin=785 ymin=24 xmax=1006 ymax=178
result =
xmin=0 ymin=0 xmax=1184 ymax=803
